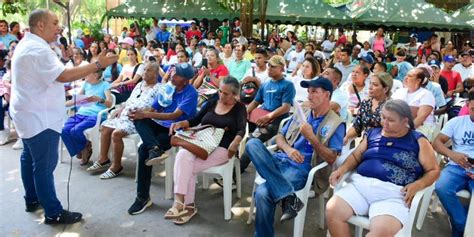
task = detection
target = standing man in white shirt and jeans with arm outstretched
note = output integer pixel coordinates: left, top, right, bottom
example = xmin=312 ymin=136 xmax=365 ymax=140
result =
xmin=10 ymin=9 xmax=117 ymax=224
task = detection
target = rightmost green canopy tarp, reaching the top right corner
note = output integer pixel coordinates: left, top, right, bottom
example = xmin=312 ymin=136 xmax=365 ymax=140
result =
xmin=348 ymin=0 xmax=471 ymax=30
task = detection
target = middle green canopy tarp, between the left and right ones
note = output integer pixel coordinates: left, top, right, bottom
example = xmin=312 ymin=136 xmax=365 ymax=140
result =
xmin=260 ymin=0 xmax=351 ymax=25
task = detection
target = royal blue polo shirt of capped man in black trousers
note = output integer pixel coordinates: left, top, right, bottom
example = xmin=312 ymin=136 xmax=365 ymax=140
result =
xmin=152 ymin=84 xmax=198 ymax=128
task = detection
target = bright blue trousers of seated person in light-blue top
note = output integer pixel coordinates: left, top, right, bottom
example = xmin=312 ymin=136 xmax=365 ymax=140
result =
xmin=61 ymin=114 xmax=97 ymax=157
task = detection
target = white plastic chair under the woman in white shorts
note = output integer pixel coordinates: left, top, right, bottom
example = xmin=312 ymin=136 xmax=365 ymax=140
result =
xmin=327 ymin=173 xmax=434 ymax=237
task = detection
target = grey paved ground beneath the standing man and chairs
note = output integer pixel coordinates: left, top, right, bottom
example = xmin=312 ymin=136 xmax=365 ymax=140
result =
xmin=0 ymin=138 xmax=450 ymax=237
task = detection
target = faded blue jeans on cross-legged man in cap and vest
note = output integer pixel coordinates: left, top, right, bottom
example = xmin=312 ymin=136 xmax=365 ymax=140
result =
xmin=246 ymin=138 xmax=309 ymax=236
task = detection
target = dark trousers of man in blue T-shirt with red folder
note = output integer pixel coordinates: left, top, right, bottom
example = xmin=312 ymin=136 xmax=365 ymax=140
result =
xmin=240 ymin=114 xmax=288 ymax=173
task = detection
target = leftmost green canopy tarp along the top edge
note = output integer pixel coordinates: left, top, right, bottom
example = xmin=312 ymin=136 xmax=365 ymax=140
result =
xmin=107 ymin=0 xmax=238 ymax=20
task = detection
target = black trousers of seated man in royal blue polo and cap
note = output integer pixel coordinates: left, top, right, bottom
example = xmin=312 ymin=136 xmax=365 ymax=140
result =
xmin=134 ymin=119 xmax=171 ymax=201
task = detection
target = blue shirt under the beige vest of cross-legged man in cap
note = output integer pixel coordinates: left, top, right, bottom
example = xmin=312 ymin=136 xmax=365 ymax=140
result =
xmin=275 ymin=113 xmax=346 ymax=172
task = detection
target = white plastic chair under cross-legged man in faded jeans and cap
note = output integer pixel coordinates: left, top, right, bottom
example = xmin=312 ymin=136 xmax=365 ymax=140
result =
xmin=247 ymin=145 xmax=328 ymax=237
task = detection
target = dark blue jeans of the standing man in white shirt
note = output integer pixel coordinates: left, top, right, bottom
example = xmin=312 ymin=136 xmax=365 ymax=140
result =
xmin=20 ymin=129 xmax=63 ymax=217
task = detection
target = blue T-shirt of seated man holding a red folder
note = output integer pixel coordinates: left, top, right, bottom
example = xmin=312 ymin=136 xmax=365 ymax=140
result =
xmin=255 ymin=79 xmax=296 ymax=111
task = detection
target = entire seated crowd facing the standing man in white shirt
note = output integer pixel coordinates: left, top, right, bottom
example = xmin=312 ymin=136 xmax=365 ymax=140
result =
xmin=0 ymin=19 xmax=474 ymax=236
